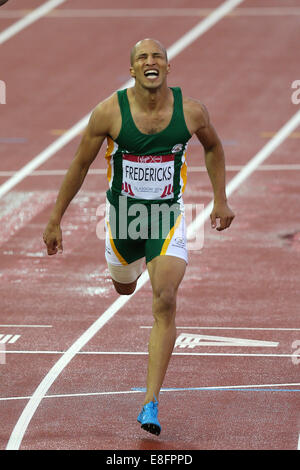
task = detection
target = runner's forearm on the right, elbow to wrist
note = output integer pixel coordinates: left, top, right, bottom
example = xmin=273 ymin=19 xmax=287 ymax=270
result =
xmin=205 ymin=143 xmax=227 ymax=202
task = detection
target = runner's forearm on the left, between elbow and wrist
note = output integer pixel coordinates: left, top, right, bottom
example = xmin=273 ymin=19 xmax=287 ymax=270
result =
xmin=50 ymin=159 xmax=88 ymax=224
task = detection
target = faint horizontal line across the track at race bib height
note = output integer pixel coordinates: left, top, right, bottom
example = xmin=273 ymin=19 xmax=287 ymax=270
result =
xmin=0 ymin=163 xmax=300 ymax=177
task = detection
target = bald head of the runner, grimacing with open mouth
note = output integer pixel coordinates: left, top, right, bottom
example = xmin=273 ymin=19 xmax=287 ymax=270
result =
xmin=130 ymin=39 xmax=169 ymax=89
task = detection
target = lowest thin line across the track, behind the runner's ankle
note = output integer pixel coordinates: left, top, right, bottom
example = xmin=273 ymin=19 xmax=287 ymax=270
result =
xmin=0 ymin=383 xmax=300 ymax=401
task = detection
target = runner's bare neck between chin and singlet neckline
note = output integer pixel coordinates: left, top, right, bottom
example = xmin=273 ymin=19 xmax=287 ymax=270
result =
xmin=131 ymin=83 xmax=171 ymax=111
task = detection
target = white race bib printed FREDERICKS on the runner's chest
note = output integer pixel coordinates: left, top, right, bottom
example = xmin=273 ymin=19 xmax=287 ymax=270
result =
xmin=122 ymin=154 xmax=174 ymax=200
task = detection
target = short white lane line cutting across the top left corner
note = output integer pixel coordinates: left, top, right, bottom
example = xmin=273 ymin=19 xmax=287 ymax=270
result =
xmin=0 ymin=0 xmax=66 ymax=44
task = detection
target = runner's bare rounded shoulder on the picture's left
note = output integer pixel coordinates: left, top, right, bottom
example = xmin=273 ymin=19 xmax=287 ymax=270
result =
xmin=89 ymin=92 xmax=120 ymax=137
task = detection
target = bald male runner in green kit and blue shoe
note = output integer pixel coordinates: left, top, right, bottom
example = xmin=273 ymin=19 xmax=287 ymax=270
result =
xmin=43 ymin=39 xmax=234 ymax=435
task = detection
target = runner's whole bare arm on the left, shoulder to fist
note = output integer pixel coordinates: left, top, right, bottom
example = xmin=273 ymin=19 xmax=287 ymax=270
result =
xmin=43 ymin=97 xmax=114 ymax=255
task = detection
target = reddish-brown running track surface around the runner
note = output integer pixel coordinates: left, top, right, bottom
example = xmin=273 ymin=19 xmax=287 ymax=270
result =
xmin=0 ymin=0 xmax=300 ymax=450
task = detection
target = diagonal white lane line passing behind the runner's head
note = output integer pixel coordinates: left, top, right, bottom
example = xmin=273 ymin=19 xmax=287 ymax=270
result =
xmin=0 ymin=0 xmax=244 ymax=198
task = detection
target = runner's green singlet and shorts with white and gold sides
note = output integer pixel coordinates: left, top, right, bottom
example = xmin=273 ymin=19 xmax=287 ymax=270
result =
xmin=105 ymin=87 xmax=191 ymax=264
